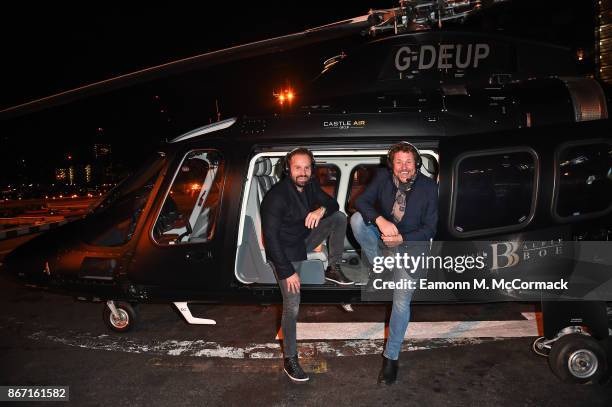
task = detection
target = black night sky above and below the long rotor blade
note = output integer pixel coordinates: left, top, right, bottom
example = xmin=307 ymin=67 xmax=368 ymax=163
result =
xmin=0 ymin=0 xmax=594 ymax=186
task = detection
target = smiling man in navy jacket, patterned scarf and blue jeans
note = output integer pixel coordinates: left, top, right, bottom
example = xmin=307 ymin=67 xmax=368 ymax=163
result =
xmin=351 ymin=142 xmax=438 ymax=384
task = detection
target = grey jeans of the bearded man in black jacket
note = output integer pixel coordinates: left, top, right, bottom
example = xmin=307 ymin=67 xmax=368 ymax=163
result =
xmin=278 ymin=211 xmax=346 ymax=357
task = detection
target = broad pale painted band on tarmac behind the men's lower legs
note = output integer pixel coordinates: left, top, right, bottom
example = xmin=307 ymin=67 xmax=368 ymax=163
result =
xmin=276 ymin=317 xmax=539 ymax=340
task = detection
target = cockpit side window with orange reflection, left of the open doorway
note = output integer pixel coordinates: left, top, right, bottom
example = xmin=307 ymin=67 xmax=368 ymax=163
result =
xmin=153 ymin=150 xmax=224 ymax=245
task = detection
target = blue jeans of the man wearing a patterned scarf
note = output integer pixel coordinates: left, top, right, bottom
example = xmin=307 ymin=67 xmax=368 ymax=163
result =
xmin=351 ymin=212 xmax=414 ymax=360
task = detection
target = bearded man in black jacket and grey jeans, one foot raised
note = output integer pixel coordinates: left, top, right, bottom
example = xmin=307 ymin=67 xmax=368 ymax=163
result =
xmin=261 ymin=148 xmax=353 ymax=381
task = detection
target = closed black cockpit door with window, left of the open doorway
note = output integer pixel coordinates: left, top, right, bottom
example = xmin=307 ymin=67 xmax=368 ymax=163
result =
xmin=129 ymin=149 xmax=226 ymax=291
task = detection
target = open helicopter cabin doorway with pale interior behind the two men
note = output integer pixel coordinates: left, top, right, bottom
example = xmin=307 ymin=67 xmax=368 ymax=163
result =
xmin=234 ymin=149 xmax=439 ymax=289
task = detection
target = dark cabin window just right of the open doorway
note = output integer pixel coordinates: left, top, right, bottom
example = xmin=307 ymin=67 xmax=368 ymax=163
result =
xmin=452 ymin=151 xmax=536 ymax=233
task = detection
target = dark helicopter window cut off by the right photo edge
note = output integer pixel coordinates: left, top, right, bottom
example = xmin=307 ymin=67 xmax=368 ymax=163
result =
xmin=556 ymin=143 xmax=612 ymax=218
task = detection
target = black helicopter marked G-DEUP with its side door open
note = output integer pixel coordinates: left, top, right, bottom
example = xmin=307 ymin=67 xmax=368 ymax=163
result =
xmin=0 ymin=0 xmax=612 ymax=383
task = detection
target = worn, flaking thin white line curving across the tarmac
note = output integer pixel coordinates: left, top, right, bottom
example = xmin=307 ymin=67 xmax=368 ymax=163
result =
xmin=28 ymin=331 xmax=506 ymax=359
